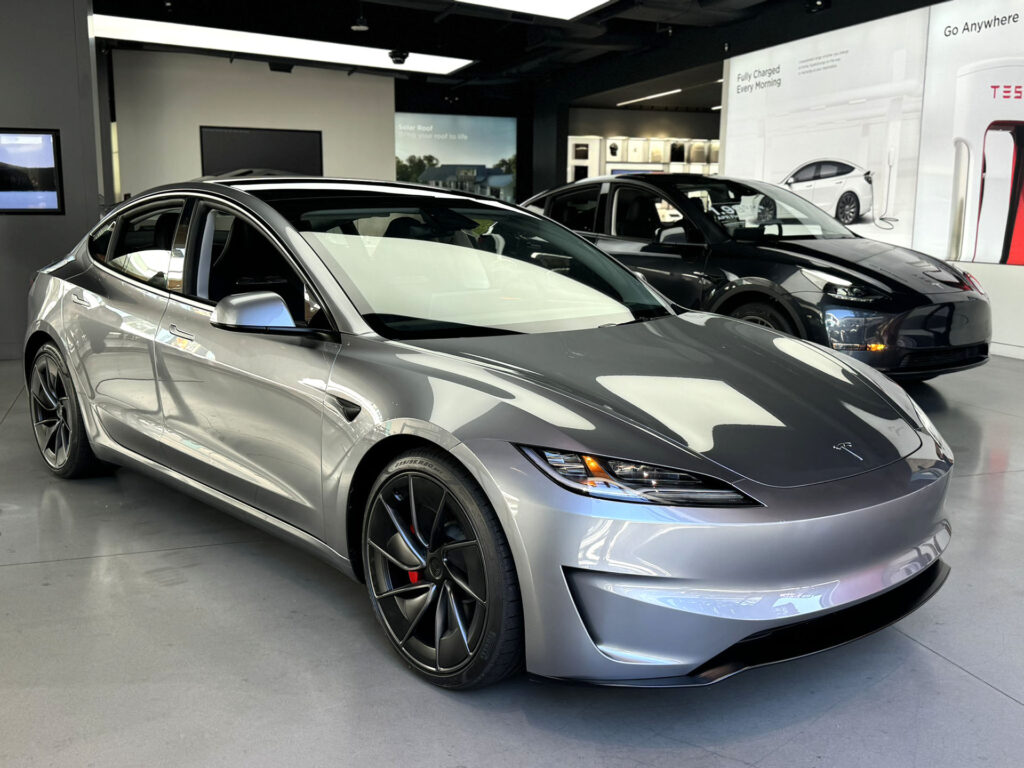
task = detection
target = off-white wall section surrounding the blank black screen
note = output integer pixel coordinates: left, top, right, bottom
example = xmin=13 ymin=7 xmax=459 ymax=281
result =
xmin=114 ymin=50 xmax=394 ymax=195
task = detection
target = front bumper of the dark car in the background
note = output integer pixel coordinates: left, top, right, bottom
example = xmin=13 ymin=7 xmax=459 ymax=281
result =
xmin=824 ymin=294 xmax=992 ymax=378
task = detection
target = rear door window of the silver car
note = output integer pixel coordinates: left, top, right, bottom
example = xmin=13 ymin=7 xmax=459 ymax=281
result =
xmin=106 ymin=200 xmax=184 ymax=290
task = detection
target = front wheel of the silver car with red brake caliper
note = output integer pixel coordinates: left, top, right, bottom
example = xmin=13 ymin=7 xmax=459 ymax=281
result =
xmin=362 ymin=449 xmax=523 ymax=689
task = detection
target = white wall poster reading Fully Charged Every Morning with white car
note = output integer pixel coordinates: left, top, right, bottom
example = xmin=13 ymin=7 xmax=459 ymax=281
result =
xmin=722 ymin=9 xmax=928 ymax=246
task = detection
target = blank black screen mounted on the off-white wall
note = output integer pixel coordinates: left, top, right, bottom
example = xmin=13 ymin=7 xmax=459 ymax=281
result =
xmin=199 ymin=125 xmax=324 ymax=176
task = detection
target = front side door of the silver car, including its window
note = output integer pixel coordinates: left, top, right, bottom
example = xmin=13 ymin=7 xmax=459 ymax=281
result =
xmin=156 ymin=202 xmax=339 ymax=537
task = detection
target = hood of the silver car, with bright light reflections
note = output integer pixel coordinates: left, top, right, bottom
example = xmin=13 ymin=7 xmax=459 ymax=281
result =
xmin=416 ymin=312 xmax=921 ymax=486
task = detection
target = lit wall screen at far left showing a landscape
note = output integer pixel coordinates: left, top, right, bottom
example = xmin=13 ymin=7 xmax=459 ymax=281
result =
xmin=0 ymin=128 xmax=63 ymax=213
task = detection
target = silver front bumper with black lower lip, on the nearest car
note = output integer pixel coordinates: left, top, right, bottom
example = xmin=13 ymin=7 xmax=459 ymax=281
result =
xmin=456 ymin=440 xmax=949 ymax=685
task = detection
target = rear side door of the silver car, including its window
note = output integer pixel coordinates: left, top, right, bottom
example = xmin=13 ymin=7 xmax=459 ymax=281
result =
xmin=63 ymin=198 xmax=184 ymax=458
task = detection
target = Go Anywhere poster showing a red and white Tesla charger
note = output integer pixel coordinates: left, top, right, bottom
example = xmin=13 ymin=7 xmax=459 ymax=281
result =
xmin=913 ymin=0 xmax=1024 ymax=264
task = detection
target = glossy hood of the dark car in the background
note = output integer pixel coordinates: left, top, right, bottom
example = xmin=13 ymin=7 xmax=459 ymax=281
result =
xmin=770 ymin=238 xmax=969 ymax=295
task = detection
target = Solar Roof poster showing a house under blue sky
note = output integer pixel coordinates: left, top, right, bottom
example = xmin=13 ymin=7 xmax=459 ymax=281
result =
xmin=394 ymin=112 xmax=516 ymax=203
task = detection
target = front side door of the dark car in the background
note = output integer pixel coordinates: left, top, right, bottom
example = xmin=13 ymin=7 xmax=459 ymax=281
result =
xmin=596 ymin=183 xmax=708 ymax=307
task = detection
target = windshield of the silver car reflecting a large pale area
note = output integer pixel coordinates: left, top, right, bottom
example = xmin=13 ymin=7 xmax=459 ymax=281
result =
xmin=252 ymin=188 xmax=670 ymax=339
